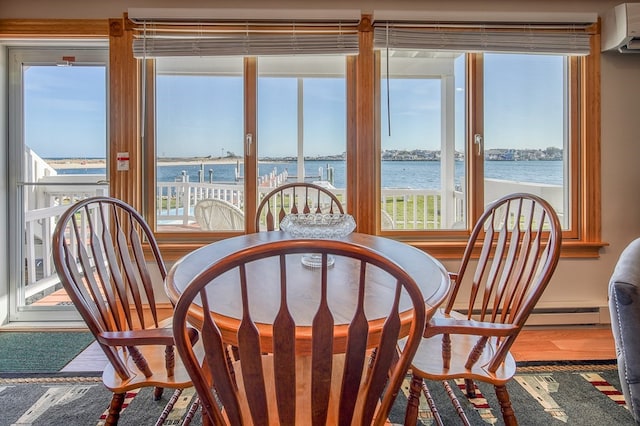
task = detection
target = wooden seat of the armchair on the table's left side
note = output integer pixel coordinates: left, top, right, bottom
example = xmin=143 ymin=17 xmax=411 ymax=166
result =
xmin=102 ymin=345 xmax=191 ymax=393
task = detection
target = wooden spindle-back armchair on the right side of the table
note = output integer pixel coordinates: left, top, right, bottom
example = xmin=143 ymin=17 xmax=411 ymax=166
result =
xmin=405 ymin=193 xmax=562 ymax=425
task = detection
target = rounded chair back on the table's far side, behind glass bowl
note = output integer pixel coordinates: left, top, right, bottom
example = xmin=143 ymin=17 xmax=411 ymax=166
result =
xmin=255 ymin=182 xmax=344 ymax=231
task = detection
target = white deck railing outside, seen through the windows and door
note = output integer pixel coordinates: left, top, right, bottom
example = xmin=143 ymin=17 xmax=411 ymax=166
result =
xmin=20 ymin=175 xmax=564 ymax=304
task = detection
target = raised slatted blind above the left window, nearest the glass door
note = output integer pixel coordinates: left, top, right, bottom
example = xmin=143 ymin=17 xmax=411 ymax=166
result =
xmin=129 ymin=10 xmax=360 ymax=58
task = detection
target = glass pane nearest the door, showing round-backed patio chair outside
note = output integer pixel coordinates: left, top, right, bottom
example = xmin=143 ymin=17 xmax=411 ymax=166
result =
xmin=154 ymin=56 xmax=245 ymax=232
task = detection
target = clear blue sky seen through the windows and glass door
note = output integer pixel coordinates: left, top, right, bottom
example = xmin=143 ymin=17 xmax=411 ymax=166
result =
xmin=24 ymin=54 xmax=563 ymax=158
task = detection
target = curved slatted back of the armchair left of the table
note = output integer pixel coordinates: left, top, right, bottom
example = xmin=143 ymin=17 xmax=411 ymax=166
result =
xmin=53 ymin=197 xmax=167 ymax=380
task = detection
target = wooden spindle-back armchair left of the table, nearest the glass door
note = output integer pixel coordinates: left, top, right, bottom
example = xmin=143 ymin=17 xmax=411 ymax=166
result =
xmin=53 ymin=196 xmax=198 ymax=425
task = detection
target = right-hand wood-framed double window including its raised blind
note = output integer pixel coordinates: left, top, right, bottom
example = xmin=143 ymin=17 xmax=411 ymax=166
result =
xmin=374 ymin=22 xmax=597 ymax=253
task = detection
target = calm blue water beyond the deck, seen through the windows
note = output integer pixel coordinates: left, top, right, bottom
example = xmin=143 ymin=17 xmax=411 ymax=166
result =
xmin=58 ymin=161 xmax=563 ymax=189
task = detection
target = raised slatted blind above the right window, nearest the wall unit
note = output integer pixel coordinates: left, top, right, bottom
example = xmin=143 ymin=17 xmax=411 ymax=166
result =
xmin=374 ymin=21 xmax=591 ymax=55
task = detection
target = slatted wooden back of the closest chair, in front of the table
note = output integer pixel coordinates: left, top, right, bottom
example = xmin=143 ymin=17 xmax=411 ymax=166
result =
xmin=174 ymin=240 xmax=425 ymax=425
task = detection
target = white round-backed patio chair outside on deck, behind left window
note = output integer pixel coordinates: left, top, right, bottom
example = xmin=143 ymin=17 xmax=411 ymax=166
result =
xmin=194 ymin=198 xmax=244 ymax=231
